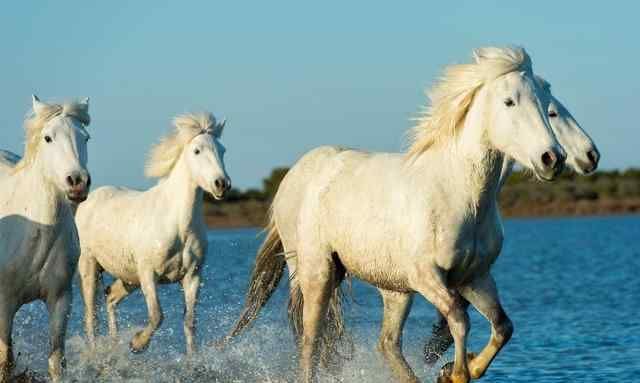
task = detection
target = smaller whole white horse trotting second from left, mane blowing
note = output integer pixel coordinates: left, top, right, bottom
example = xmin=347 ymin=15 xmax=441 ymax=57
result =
xmin=76 ymin=114 xmax=231 ymax=353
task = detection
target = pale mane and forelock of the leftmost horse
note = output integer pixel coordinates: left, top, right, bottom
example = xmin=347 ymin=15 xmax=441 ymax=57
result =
xmin=13 ymin=101 xmax=91 ymax=173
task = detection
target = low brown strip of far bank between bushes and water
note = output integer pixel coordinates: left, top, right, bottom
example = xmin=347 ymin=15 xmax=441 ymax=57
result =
xmin=205 ymin=198 xmax=640 ymax=229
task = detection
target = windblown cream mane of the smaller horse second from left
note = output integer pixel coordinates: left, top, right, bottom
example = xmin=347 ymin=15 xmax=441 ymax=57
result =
xmin=145 ymin=113 xmax=225 ymax=178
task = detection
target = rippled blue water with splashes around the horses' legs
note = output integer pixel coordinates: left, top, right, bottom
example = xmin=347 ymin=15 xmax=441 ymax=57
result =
xmin=14 ymin=216 xmax=640 ymax=383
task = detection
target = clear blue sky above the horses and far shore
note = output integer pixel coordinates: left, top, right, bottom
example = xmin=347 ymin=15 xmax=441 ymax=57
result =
xmin=0 ymin=1 xmax=640 ymax=188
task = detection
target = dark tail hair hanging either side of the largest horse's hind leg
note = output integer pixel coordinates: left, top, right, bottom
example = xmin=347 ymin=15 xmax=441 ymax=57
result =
xmin=287 ymin=257 xmax=353 ymax=367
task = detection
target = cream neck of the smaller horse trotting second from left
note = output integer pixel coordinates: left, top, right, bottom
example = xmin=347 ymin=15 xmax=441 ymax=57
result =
xmin=157 ymin=158 xmax=203 ymax=231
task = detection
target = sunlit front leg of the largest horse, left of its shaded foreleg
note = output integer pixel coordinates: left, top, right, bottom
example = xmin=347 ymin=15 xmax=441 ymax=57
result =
xmin=412 ymin=265 xmax=470 ymax=383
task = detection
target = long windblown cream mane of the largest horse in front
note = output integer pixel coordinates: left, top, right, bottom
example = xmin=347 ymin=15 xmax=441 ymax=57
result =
xmin=407 ymin=47 xmax=532 ymax=158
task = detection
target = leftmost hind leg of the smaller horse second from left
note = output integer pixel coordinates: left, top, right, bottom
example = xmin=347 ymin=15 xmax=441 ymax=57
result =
xmin=78 ymin=254 xmax=98 ymax=347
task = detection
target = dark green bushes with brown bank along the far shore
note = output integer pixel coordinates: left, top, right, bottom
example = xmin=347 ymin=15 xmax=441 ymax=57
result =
xmin=205 ymin=167 xmax=640 ymax=227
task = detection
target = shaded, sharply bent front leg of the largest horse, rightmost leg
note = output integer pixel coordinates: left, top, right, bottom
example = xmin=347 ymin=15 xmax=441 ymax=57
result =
xmin=459 ymin=273 xmax=513 ymax=379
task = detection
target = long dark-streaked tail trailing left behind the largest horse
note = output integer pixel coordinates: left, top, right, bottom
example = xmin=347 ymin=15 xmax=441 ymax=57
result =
xmin=223 ymin=213 xmax=286 ymax=343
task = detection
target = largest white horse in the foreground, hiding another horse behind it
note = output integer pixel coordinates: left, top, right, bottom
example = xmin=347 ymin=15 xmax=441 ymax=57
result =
xmin=230 ymin=48 xmax=565 ymax=383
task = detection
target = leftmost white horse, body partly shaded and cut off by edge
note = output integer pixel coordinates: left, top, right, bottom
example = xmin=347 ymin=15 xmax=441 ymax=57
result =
xmin=0 ymin=96 xmax=91 ymax=382
